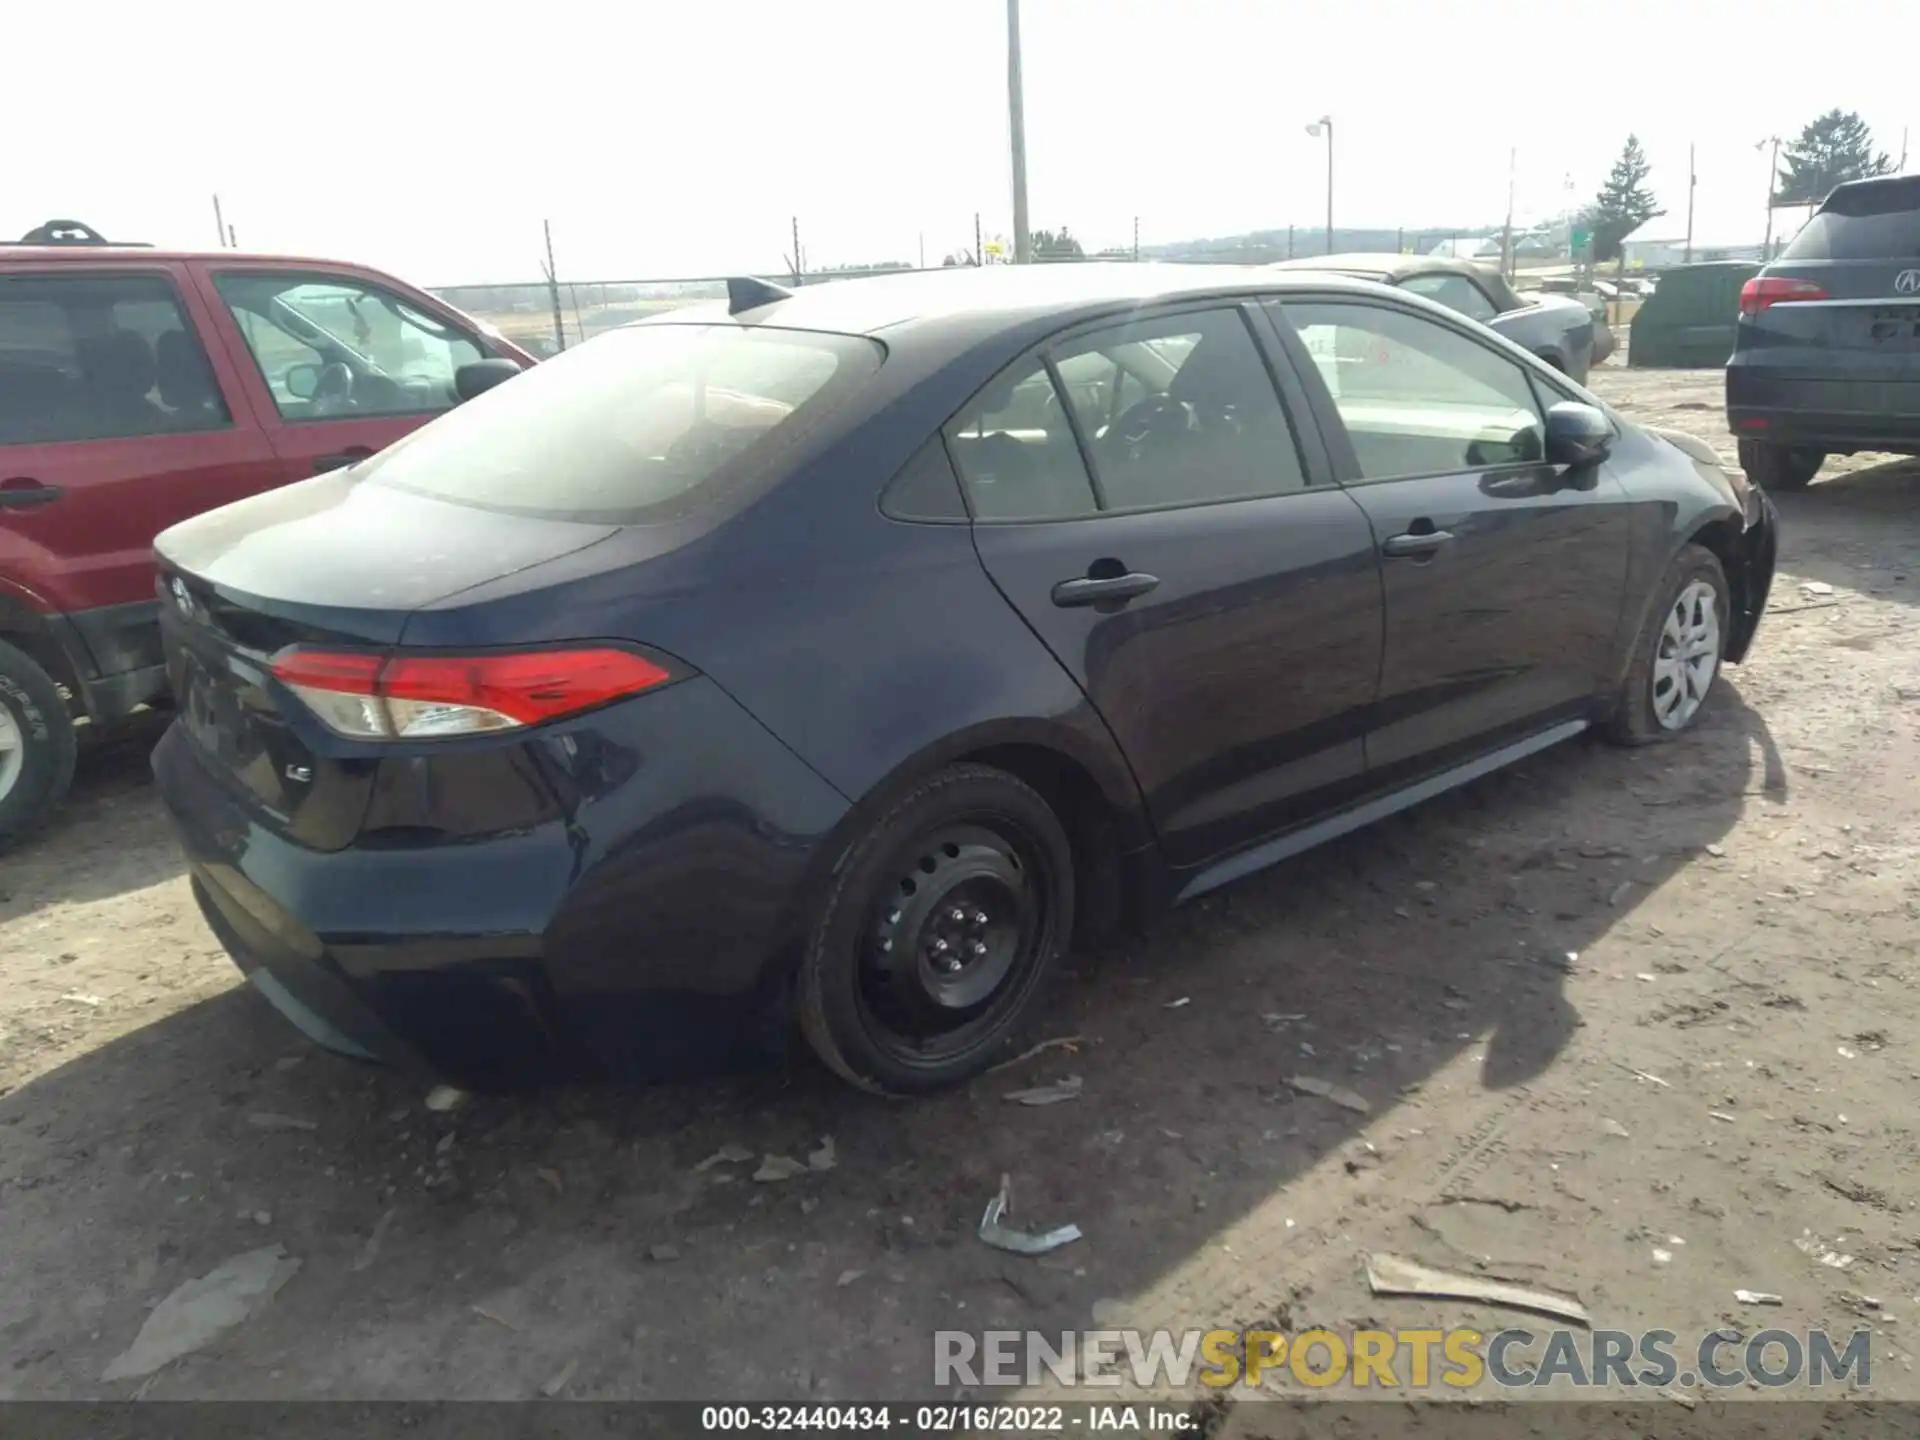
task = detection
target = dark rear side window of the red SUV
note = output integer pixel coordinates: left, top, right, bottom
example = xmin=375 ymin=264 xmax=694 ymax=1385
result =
xmin=0 ymin=275 xmax=232 ymax=445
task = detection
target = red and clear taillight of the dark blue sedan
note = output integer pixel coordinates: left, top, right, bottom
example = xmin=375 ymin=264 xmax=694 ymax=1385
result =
xmin=273 ymin=649 xmax=672 ymax=739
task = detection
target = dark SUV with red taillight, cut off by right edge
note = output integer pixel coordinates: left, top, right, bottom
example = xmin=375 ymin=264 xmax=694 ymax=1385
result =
xmin=1726 ymin=175 xmax=1920 ymax=490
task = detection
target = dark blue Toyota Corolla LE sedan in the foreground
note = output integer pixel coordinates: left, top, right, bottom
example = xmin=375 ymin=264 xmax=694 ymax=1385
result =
xmin=154 ymin=265 xmax=1776 ymax=1092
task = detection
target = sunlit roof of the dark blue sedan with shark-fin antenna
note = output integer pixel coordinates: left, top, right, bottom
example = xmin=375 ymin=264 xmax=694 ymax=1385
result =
xmin=639 ymin=261 xmax=1397 ymax=344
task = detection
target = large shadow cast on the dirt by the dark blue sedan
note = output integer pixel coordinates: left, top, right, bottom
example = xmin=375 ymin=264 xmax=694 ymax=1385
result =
xmin=0 ymin=684 xmax=1788 ymax=1400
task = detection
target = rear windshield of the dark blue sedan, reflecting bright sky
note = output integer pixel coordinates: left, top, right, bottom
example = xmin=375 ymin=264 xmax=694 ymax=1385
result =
xmin=363 ymin=324 xmax=883 ymax=524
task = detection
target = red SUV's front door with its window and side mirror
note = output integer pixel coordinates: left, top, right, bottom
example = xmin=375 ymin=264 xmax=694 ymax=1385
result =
xmin=194 ymin=257 xmax=530 ymax=482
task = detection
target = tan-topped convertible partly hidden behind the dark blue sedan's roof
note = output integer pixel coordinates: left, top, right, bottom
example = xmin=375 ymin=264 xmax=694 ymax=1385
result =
xmin=1271 ymin=255 xmax=1613 ymax=384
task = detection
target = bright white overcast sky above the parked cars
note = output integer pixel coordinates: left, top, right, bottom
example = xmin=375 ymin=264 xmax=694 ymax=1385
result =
xmin=0 ymin=0 xmax=1920 ymax=284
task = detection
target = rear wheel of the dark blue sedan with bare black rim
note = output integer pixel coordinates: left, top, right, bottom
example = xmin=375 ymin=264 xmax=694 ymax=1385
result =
xmin=799 ymin=764 xmax=1073 ymax=1094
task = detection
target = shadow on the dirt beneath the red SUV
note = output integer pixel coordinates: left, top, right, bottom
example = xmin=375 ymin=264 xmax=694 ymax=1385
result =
xmin=0 ymin=710 xmax=186 ymax=922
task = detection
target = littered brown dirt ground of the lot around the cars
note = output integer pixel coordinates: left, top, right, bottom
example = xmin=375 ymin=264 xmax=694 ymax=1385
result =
xmin=0 ymin=367 xmax=1920 ymax=1434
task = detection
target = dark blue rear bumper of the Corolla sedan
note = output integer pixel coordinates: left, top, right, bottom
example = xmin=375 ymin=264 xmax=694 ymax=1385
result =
xmin=154 ymin=678 xmax=847 ymax=1087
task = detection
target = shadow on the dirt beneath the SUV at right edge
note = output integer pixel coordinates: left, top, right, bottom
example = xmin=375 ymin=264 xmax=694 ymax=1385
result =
xmin=1770 ymin=459 xmax=1920 ymax=614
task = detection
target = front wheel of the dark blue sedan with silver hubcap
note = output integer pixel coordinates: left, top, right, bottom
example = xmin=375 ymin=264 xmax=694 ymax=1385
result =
xmin=1607 ymin=545 xmax=1732 ymax=745
